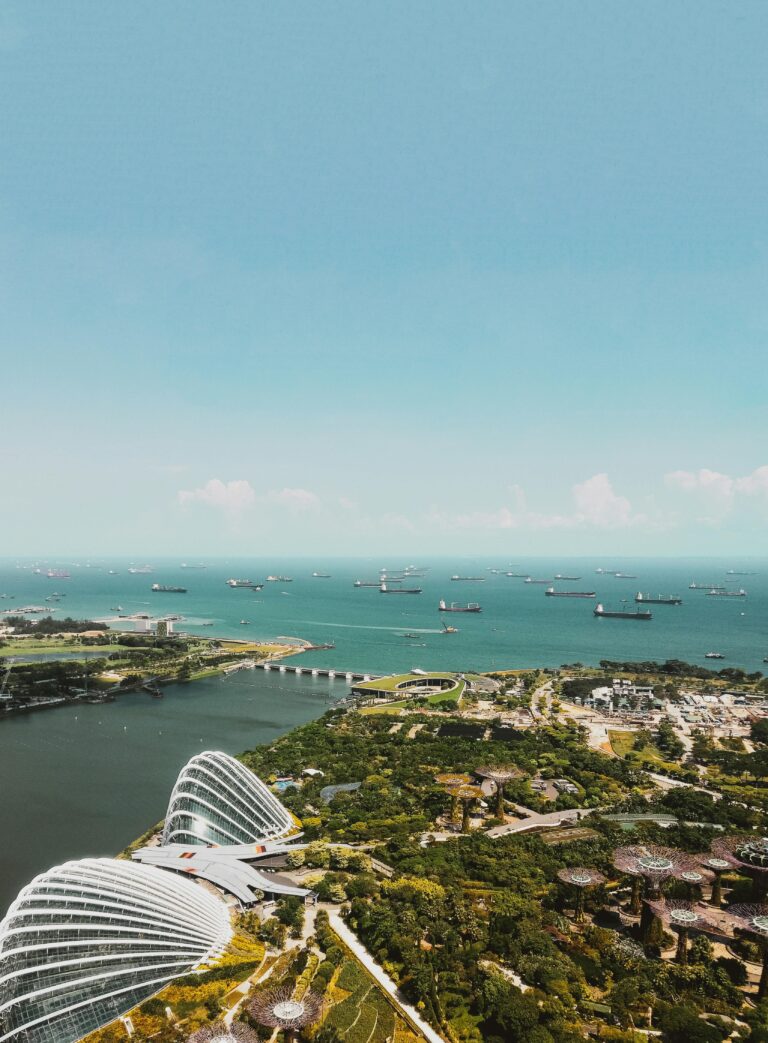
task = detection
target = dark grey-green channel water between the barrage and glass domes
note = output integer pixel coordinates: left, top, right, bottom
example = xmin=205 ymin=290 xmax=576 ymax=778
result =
xmin=0 ymin=671 xmax=349 ymax=918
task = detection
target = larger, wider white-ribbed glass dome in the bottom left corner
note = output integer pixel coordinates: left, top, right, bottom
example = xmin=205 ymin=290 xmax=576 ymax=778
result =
xmin=0 ymin=858 xmax=232 ymax=1043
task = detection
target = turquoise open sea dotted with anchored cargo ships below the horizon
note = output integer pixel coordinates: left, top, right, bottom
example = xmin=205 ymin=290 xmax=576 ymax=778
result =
xmin=0 ymin=558 xmax=768 ymax=672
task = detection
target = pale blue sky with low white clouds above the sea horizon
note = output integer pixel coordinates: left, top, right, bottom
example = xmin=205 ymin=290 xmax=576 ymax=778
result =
xmin=0 ymin=0 xmax=768 ymax=555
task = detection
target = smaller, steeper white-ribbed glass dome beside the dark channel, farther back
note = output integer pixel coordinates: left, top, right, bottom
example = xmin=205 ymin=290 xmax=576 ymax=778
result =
xmin=163 ymin=752 xmax=295 ymax=845
